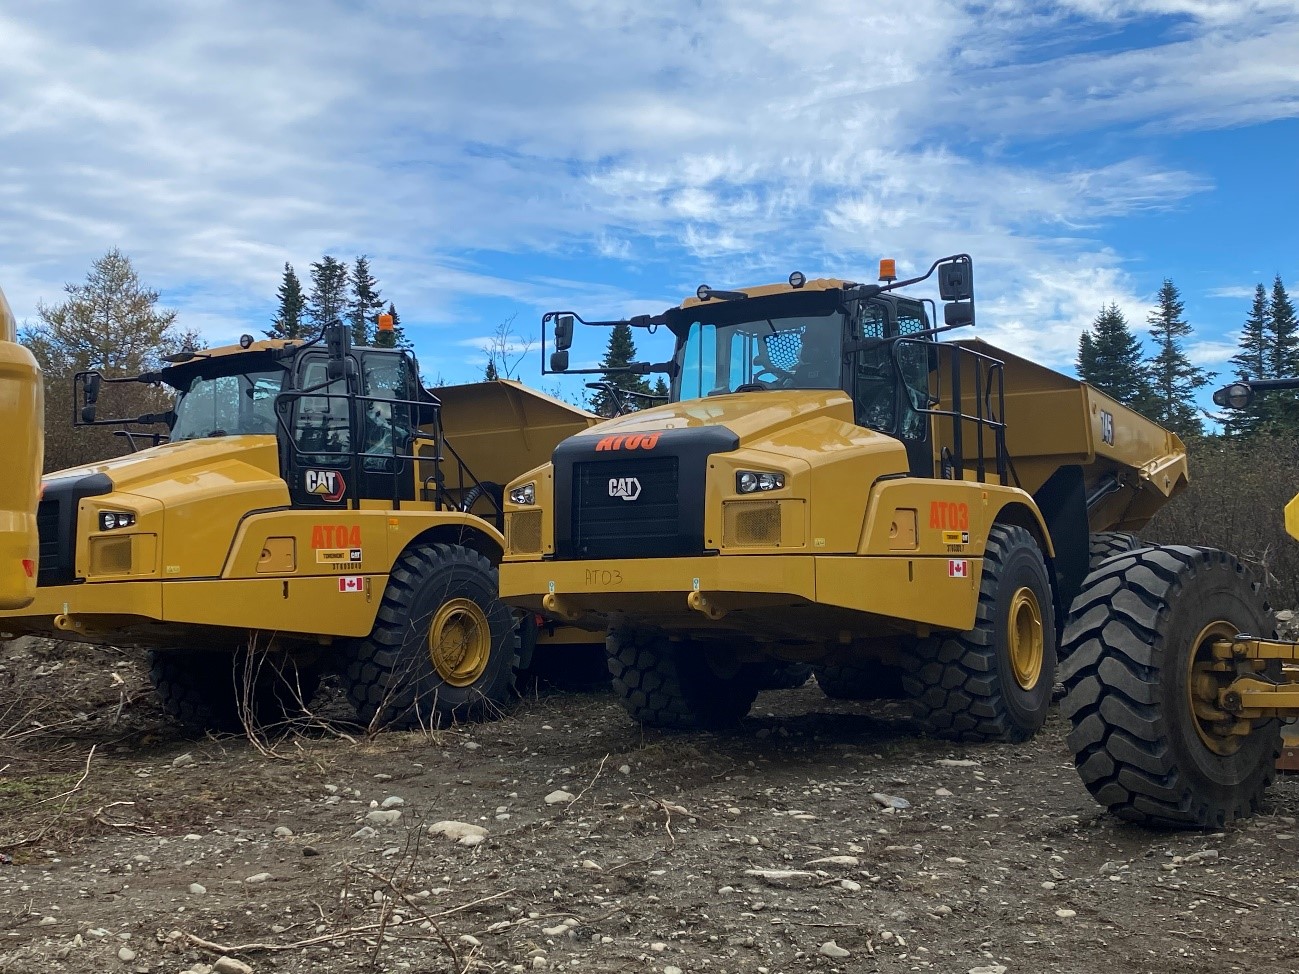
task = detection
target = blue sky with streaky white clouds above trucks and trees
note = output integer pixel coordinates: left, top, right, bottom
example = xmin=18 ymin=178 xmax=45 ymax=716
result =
xmin=0 ymin=0 xmax=1299 ymax=397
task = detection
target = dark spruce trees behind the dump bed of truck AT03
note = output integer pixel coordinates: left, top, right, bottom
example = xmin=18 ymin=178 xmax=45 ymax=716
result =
xmin=1076 ymin=274 xmax=1299 ymax=439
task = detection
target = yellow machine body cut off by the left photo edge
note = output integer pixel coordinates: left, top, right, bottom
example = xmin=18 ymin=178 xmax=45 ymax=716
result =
xmin=0 ymin=291 xmax=44 ymax=609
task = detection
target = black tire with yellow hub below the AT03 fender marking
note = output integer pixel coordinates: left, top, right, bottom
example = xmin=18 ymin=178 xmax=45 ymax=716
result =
xmin=903 ymin=525 xmax=1056 ymax=742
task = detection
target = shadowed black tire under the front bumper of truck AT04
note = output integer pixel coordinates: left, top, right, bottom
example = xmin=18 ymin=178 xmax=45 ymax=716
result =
xmin=149 ymin=649 xmax=321 ymax=732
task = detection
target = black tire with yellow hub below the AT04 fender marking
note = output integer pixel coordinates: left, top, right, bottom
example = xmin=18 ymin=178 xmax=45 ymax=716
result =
xmin=343 ymin=544 xmax=518 ymax=730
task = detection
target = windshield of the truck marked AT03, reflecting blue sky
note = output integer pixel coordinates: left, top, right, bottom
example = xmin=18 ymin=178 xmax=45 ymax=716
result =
xmin=673 ymin=312 xmax=844 ymax=400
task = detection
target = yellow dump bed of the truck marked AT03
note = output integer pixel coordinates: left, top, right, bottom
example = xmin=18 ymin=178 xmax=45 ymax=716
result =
xmin=938 ymin=339 xmax=1187 ymax=531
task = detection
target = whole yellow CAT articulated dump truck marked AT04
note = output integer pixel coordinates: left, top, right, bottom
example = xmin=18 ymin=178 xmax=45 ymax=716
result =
xmin=0 ymin=322 xmax=595 ymax=727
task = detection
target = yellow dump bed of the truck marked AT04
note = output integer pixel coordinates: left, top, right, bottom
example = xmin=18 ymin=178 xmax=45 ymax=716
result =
xmin=431 ymin=379 xmax=601 ymax=486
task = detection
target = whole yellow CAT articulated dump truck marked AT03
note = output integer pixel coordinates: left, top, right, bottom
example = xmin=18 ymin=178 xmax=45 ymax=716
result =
xmin=500 ymin=256 xmax=1186 ymax=740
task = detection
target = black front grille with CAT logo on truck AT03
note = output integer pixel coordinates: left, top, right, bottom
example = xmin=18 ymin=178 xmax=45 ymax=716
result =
xmin=573 ymin=457 xmax=685 ymax=558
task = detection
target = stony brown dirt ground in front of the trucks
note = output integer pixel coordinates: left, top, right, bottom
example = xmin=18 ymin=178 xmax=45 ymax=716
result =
xmin=0 ymin=642 xmax=1299 ymax=974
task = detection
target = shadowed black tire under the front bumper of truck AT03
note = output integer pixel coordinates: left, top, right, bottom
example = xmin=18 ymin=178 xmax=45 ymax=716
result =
xmin=605 ymin=629 xmax=757 ymax=730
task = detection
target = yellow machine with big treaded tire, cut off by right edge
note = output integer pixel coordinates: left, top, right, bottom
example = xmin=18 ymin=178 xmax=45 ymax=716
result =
xmin=1060 ymin=378 xmax=1299 ymax=829
